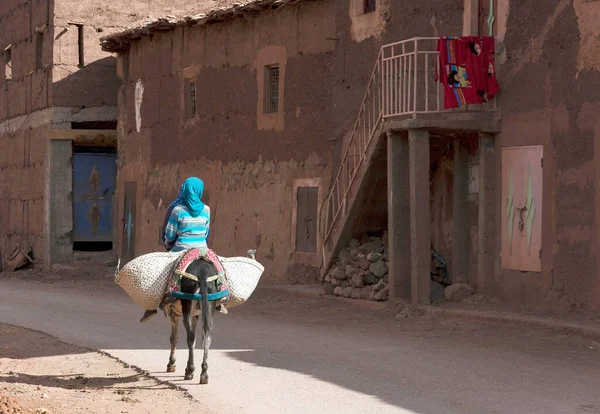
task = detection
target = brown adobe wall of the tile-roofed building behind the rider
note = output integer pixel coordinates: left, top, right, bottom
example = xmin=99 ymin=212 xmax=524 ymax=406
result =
xmin=118 ymin=0 xmax=462 ymax=283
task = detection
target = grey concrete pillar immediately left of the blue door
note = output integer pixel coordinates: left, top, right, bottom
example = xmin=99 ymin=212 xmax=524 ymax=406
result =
xmin=44 ymin=140 xmax=73 ymax=270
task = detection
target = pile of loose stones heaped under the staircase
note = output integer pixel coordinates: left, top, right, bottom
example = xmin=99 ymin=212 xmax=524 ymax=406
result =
xmin=323 ymin=232 xmax=389 ymax=301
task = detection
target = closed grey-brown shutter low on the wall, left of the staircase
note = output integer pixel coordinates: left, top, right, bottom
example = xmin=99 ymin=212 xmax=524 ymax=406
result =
xmin=296 ymin=187 xmax=319 ymax=253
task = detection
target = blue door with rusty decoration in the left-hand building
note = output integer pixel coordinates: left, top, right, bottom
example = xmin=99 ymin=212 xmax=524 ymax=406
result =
xmin=73 ymin=153 xmax=116 ymax=242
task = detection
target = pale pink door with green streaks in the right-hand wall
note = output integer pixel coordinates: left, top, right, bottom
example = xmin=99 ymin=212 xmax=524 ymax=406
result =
xmin=501 ymin=146 xmax=543 ymax=272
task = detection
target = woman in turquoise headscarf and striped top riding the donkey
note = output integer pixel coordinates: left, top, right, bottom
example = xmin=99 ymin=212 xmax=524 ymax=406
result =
xmin=140 ymin=177 xmax=227 ymax=322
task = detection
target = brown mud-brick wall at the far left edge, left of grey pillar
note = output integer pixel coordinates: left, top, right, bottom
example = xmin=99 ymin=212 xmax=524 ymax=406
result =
xmin=0 ymin=0 xmax=52 ymax=267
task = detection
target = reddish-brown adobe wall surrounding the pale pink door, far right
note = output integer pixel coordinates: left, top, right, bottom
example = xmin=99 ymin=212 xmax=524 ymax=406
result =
xmin=495 ymin=0 xmax=600 ymax=309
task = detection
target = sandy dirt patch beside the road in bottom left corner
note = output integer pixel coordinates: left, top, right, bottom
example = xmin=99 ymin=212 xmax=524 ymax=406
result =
xmin=0 ymin=324 xmax=209 ymax=414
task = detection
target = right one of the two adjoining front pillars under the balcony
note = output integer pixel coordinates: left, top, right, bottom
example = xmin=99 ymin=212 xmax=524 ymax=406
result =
xmin=408 ymin=129 xmax=431 ymax=306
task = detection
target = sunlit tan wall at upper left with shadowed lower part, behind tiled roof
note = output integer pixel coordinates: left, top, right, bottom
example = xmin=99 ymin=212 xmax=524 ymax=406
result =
xmin=53 ymin=0 xmax=202 ymax=108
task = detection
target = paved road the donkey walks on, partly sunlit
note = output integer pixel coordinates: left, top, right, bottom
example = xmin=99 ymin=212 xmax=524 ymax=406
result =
xmin=0 ymin=280 xmax=600 ymax=414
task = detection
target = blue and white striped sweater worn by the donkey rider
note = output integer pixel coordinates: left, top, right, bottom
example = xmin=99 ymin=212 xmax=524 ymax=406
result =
xmin=165 ymin=205 xmax=210 ymax=252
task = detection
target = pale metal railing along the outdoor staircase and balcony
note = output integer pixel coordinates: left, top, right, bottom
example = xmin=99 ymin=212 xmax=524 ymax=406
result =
xmin=319 ymin=37 xmax=496 ymax=260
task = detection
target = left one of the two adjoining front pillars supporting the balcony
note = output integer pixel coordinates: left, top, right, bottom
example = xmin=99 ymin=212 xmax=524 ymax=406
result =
xmin=387 ymin=132 xmax=411 ymax=304
